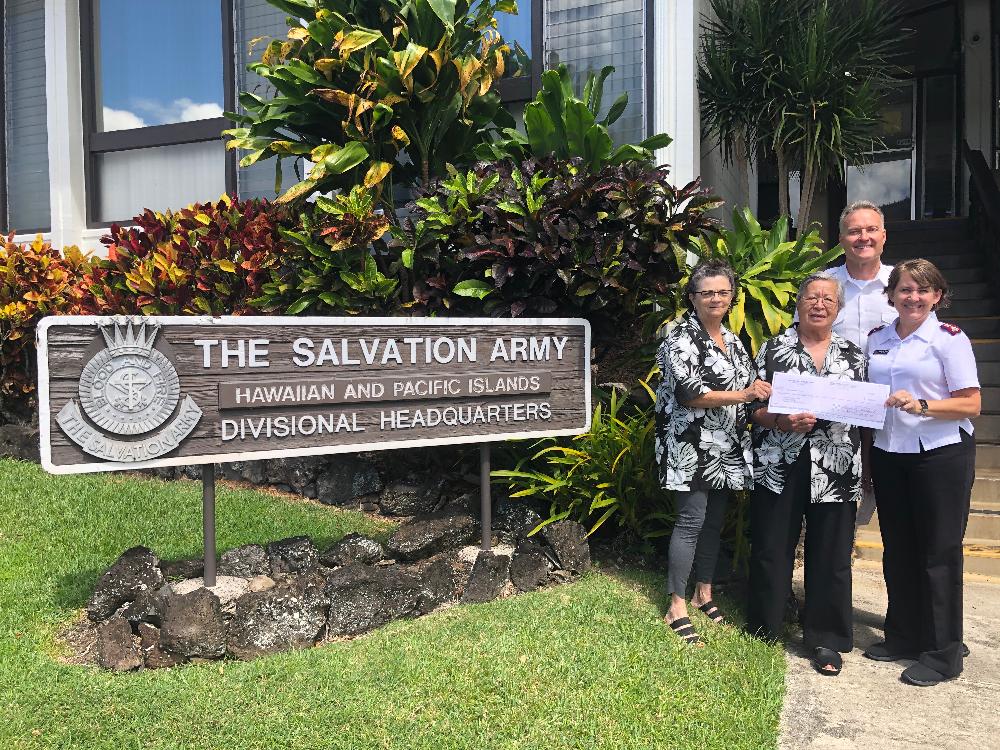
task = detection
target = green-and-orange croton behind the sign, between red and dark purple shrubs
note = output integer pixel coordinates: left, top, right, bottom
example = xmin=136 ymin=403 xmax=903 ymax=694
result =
xmin=251 ymin=186 xmax=399 ymax=315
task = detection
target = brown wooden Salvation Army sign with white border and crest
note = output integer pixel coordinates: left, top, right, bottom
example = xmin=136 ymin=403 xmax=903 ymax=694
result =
xmin=37 ymin=316 xmax=591 ymax=474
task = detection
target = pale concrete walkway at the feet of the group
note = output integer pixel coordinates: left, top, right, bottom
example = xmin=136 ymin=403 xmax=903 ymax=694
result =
xmin=779 ymin=561 xmax=1000 ymax=750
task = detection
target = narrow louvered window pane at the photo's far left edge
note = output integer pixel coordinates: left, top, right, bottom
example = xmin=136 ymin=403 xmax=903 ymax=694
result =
xmin=3 ymin=0 xmax=49 ymax=232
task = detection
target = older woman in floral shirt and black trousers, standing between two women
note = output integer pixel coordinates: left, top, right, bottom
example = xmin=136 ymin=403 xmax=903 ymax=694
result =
xmin=747 ymin=273 xmax=865 ymax=675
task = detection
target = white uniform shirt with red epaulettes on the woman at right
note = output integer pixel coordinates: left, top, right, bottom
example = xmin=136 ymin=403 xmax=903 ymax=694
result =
xmin=868 ymin=313 xmax=979 ymax=453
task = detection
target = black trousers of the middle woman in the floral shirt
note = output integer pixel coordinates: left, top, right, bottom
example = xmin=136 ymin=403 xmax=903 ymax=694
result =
xmin=747 ymin=450 xmax=857 ymax=652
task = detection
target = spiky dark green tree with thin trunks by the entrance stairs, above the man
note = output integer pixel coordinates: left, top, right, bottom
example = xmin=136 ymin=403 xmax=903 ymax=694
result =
xmin=698 ymin=0 xmax=901 ymax=227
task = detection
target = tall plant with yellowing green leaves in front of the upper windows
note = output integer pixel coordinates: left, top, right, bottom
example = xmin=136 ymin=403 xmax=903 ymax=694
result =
xmin=226 ymin=0 xmax=517 ymax=201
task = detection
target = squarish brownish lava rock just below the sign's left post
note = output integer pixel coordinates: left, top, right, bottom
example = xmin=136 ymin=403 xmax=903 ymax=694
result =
xmin=160 ymin=588 xmax=226 ymax=659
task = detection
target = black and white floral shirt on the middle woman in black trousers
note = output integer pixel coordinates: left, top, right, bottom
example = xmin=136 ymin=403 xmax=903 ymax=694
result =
xmin=751 ymin=326 xmax=868 ymax=503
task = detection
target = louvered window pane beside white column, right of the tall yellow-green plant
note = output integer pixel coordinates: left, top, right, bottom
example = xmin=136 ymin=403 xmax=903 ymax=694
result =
xmin=545 ymin=0 xmax=646 ymax=144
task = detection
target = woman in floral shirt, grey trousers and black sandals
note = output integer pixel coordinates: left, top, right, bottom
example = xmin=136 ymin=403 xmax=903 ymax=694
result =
xmin=656 ymin=260 xmax=771 ymax=644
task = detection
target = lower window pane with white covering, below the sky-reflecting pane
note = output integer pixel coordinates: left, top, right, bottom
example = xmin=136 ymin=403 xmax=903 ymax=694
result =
xmin=94 ymin=141 xmax=226 ymax=222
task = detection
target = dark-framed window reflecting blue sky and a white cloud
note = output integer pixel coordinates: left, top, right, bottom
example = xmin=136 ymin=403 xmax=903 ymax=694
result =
xmin=81 ymin=0 xmax=235 ymax=225
